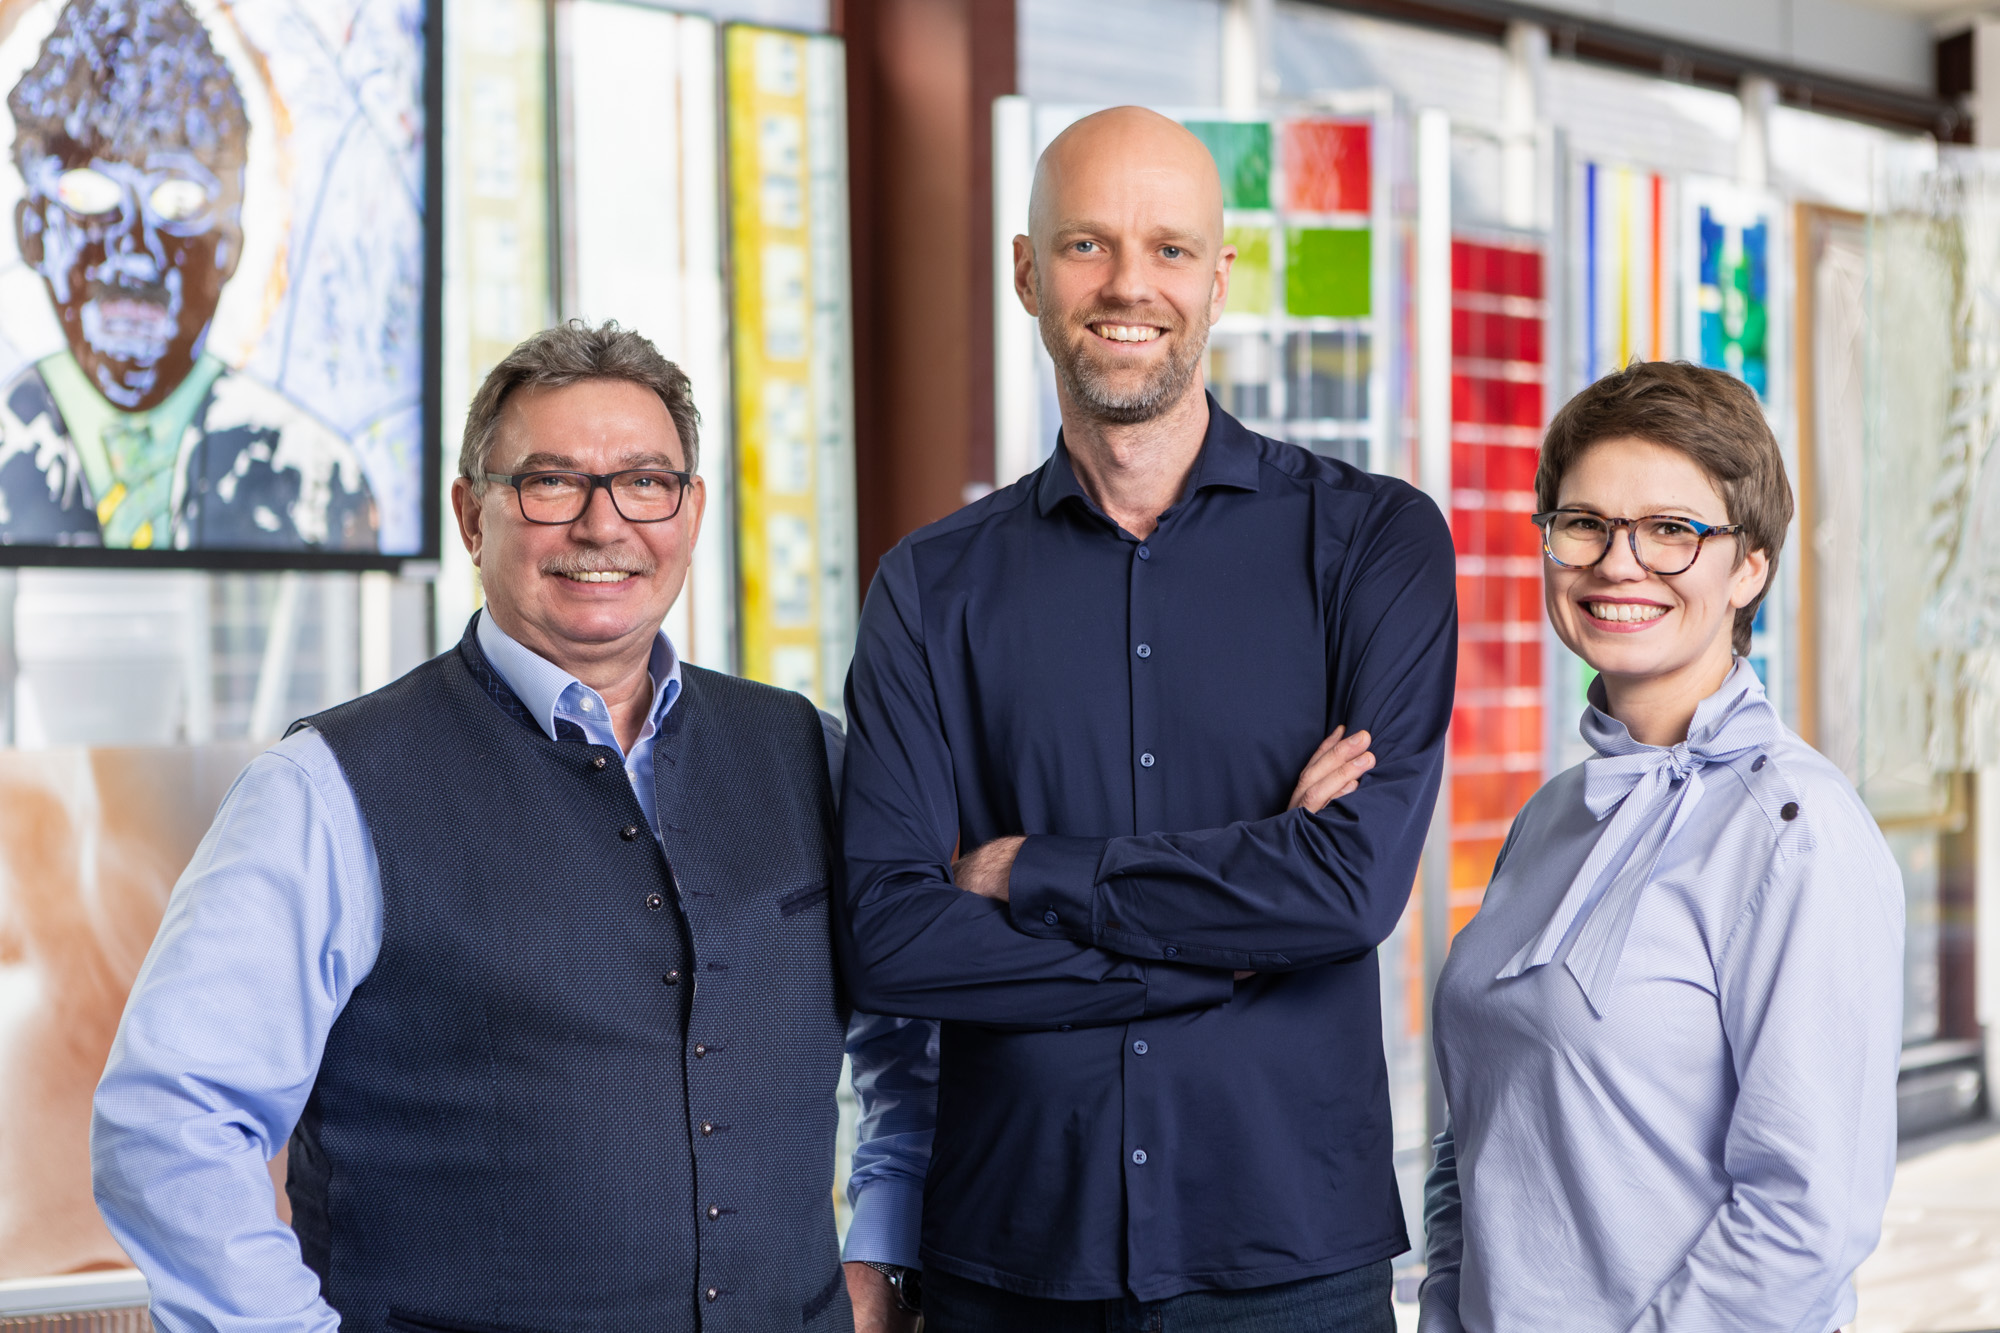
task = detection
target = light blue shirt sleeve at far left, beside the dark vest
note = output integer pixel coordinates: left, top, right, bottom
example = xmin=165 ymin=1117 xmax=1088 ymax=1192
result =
xmin=90 ymin=733 xmax=382 ymax=1333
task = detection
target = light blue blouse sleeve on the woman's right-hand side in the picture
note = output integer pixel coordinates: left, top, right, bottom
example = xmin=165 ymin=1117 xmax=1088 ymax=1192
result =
xmin=1632 ymin=791 xmax=1904 ymax=1333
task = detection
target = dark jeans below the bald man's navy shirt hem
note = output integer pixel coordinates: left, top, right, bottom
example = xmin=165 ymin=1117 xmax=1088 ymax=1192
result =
xmin=924 ymin=1259 xmax=1396 ymax=1333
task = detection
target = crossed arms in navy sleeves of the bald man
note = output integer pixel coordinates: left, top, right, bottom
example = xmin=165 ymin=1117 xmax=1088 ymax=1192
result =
xmin=836 ymin=492 xmax=1456 ymax=1029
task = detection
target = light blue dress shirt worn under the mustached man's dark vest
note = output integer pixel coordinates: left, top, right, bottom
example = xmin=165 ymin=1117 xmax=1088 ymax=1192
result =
xmin=90 ymin=614 xmax=938 ymax=1333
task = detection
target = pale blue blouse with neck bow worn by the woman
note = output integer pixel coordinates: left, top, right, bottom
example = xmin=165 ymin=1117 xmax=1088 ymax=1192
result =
xmin=1420 ymin=660 xmax=1904 ymax=1333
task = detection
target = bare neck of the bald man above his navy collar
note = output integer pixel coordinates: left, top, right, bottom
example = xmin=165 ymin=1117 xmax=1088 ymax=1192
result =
xmin=1058 ymin=380 xmax=1208 ymax=538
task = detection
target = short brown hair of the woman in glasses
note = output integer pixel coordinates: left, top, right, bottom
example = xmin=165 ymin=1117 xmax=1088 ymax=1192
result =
xmin=1534 ymin=360 xmax=1792 ymax=652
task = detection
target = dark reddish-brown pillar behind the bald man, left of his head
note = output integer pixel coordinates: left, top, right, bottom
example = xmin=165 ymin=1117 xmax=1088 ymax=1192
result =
xmin=834 ymin=0 xmax=1014 ymax=580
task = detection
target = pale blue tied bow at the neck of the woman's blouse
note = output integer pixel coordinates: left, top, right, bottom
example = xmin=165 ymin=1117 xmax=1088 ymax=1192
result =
xmin=1498 ymin=660 xmax=1780 ymax=1017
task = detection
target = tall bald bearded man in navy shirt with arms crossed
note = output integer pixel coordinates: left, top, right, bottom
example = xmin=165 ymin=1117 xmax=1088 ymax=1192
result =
xmin=836 ymin=108 xmax=1456 ymax=1333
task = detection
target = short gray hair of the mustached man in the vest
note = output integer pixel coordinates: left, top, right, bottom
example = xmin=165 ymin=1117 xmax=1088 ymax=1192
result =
xmin=458 ymin=320 xmax=702 ymax=490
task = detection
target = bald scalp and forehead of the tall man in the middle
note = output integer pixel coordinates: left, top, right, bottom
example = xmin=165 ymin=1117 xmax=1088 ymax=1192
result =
xmin=1028 ymin=106 xmax=1222 ymax=252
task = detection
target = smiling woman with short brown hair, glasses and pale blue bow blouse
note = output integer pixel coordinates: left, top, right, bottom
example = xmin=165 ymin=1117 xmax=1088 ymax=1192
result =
xmin=1422 ymin=362 xmax=1902 ymax=1333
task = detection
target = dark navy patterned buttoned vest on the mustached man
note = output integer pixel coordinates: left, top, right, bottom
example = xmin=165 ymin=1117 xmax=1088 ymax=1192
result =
xmin=286 ymin=628 xmax=852 ymax=1333
